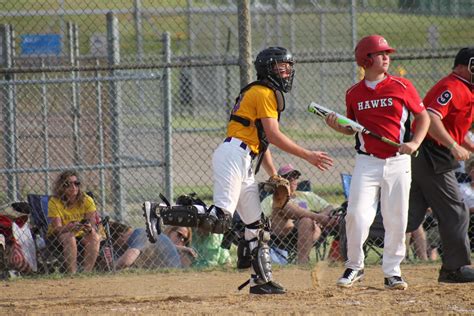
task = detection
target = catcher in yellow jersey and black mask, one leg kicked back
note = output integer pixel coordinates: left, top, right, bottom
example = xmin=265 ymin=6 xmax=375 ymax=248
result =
xmin=143 ymin=47 xmax=332 ymax=294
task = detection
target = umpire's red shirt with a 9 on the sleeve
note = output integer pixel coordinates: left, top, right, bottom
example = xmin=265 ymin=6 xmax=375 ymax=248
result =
xmin=420 ymin=73 xmax=474 ymax=144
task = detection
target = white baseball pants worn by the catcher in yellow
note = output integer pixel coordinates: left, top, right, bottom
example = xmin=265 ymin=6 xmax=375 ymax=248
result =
xmin=212 ymin=137 xmax=262 ymax=224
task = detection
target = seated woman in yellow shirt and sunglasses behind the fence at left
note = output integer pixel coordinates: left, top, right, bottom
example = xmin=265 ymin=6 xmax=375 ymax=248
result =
xmin=47 ymin=170 xmax=101 ymax=273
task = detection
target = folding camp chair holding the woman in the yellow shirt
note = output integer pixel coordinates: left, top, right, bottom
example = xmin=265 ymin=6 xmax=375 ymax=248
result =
xmin=27 ymin=192 xmax=115 ymax=274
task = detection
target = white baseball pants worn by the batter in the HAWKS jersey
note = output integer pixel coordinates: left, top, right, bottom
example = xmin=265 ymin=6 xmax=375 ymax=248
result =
xmin=346 ymin=154 xmax=411 ymax=277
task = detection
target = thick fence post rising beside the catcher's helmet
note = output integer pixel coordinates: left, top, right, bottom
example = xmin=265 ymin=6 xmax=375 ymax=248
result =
xmin=237 ymin=0 xmax=252 ymax=87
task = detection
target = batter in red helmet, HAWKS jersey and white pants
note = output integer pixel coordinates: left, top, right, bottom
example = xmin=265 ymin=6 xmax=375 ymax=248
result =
xmin=326 ymin=35 xmax=429 ymax=290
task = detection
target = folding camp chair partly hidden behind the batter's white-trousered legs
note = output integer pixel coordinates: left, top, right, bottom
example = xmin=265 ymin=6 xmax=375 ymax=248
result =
xmin=339 ymin=173 xmax=385 ymax=263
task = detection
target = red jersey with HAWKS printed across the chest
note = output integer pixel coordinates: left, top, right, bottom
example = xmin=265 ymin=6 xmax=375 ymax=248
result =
xmin=346 ymin=74 xmax=424 ymax=159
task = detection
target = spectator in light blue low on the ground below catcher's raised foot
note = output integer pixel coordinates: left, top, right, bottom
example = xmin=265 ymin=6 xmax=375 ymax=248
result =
xmin=110 ymin=222 xmax=182 ymax=270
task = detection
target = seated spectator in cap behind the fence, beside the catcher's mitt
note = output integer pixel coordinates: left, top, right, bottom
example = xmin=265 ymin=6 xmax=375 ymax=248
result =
xmin=262 ymin=164 xmax=337 ymax=264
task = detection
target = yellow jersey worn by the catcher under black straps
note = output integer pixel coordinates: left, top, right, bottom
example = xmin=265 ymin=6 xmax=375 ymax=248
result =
xmin=227 ymin=85 xmax=278 ymax=154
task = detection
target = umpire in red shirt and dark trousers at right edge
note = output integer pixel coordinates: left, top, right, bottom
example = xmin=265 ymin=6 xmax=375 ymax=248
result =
xmin=408 ymin=47 xmax=474 ymax=283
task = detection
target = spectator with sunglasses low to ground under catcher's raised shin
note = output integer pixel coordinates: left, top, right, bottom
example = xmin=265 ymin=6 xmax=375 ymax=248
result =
xmin=163 ymin=226 xmax=197 ymax=268
